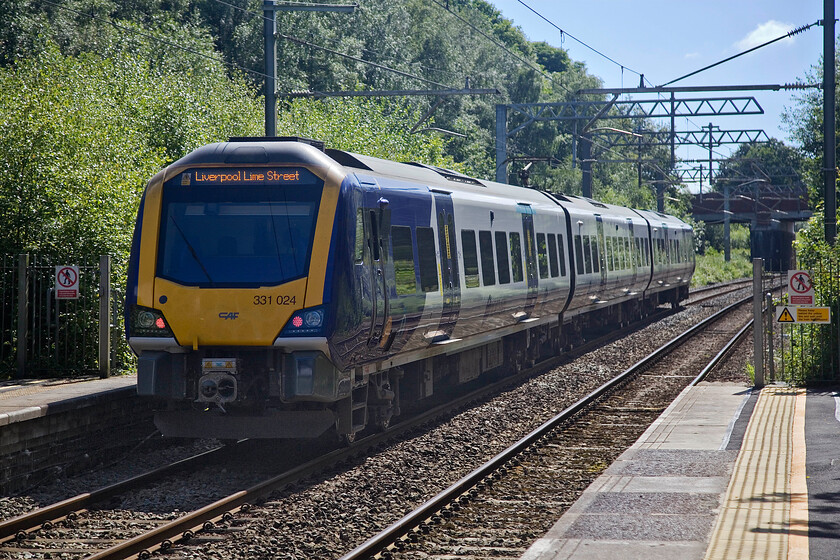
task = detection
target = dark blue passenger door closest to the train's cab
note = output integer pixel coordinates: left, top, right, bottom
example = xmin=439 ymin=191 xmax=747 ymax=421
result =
xmin=432 ymin=191 xmax=461 ymax=336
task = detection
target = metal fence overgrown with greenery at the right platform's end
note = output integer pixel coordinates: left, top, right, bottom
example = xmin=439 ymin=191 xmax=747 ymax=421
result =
xmin=754 ymin=253 xmax=840 ymax=385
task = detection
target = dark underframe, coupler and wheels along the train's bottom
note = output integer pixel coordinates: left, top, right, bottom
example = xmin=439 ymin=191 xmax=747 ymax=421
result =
xmin=144 ymin=286 xmax=688 ymax=441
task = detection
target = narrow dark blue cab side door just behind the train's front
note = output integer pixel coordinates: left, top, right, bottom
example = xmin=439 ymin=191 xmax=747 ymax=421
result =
xmin=364 ymin=192 xmax=391 ymax=346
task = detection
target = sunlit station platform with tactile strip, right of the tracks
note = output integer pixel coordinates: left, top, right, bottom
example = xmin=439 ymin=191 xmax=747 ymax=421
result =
xmin=522 ymin=382 xmax=840 ymax=560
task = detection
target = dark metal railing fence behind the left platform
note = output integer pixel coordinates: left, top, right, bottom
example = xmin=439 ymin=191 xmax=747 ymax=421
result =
xmin=0 ymin=255 xmax=130 ymax=379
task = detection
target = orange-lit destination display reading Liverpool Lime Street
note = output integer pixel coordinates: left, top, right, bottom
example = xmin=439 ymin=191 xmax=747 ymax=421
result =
xmin=181 ymin=167 xmax=319 ymax=187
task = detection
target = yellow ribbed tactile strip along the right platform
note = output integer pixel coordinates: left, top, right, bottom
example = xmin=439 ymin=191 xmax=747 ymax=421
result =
xmin=705 ymin=387 xmax=808 ymax=560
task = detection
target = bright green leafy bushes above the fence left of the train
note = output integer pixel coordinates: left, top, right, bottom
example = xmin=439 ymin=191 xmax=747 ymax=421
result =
xmin=0 ymin=41 xmax=259 ymax=261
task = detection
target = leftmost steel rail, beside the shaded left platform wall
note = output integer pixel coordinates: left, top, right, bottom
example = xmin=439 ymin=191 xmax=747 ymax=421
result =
xmin=0 ymin=447 xmax=226 ymax=542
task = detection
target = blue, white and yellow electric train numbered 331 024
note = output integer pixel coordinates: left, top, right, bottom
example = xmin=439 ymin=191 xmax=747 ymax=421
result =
xmin=121 ymin=138 xmax=694 ymax=439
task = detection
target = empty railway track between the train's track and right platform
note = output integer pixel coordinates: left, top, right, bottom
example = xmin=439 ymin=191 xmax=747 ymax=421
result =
xmin=342 ymin=298 xmax=751 ymax=560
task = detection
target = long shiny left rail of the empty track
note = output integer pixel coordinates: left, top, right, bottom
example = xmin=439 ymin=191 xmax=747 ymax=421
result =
xmin=340 ymin=296 xmax=752 ymax=560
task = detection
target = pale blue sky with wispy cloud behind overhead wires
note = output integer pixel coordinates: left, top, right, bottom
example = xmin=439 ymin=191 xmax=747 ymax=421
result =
xmin=489 ymin=0 xmax=828 ymax=191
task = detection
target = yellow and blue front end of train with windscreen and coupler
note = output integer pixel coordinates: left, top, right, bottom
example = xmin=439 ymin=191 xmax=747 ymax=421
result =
xmin=126 ymin=142 xmax=350 ymax=439
